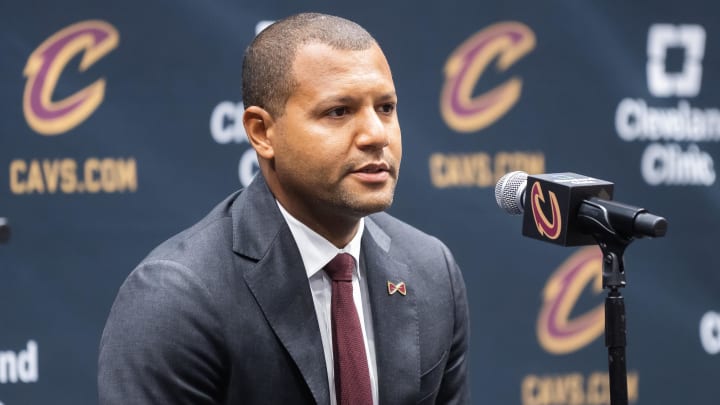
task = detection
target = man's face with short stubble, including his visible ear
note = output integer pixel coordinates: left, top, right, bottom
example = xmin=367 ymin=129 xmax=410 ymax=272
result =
xmin=268 ymin=43 xmax=402 ymax=225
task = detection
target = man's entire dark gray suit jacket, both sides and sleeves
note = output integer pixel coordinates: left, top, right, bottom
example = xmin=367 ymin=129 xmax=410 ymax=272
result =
xmin=98 ymin=175 xmax=469 ymax=405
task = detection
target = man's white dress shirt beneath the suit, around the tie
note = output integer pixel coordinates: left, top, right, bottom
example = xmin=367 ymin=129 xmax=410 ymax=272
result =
xmin=275 ymin=200 xmax=378 ymax=405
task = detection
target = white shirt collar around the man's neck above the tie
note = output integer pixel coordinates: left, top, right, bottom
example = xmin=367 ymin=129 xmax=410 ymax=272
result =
xmin=275 ymin=200 xmax=365 ymax=278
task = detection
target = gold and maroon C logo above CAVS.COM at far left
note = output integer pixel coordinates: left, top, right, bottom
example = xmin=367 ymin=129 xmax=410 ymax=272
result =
xmin=23 ymin=20 xmax=120 ymax=135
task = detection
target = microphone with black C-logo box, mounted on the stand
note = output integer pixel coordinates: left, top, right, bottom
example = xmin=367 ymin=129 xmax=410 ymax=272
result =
xmin=495 ymin=171 xmax=667 ymax=246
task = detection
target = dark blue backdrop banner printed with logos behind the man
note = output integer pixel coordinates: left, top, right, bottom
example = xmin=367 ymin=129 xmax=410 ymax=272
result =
xmin=0 ymin=0 xmax=720 ymax=405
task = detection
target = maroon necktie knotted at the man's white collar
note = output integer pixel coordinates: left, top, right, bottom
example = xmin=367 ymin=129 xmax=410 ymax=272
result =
xmin=325 ymin=253 xmax=372 ymax=405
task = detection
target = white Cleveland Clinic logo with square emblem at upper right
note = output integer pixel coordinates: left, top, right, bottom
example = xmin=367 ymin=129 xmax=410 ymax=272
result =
xmin=615 ymin=24 xmax=720 ymax=186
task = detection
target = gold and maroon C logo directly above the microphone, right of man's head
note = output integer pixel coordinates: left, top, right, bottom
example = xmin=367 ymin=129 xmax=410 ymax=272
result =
xmin=440 ymin=22 xmax=535 ymax=132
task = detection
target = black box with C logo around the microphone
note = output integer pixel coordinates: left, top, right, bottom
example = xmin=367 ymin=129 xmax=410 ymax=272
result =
xmin=522 ymin=172 xmax=613 ymax=246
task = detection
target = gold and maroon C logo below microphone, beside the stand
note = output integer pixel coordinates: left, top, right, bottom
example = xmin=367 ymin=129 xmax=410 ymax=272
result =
xmin=537 ymin=246 xmax=605 ymax=354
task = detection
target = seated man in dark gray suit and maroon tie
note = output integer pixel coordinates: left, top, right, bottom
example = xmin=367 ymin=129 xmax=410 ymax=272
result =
xmin=98 ymin=14 xmax=469 ymax=405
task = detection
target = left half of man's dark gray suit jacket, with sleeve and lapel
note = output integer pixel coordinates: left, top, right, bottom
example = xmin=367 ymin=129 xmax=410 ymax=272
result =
xmin=98 ymin=178 xmax=329 ymax=405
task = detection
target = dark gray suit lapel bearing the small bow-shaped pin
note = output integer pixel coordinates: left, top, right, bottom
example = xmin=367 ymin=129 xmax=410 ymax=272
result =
xmin=362 ymin=218 xmax=420 ymax=404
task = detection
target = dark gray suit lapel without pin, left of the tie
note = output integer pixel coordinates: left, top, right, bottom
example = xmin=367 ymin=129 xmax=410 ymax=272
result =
xmin=232 ymin=175 xmax=330 ymax=404
